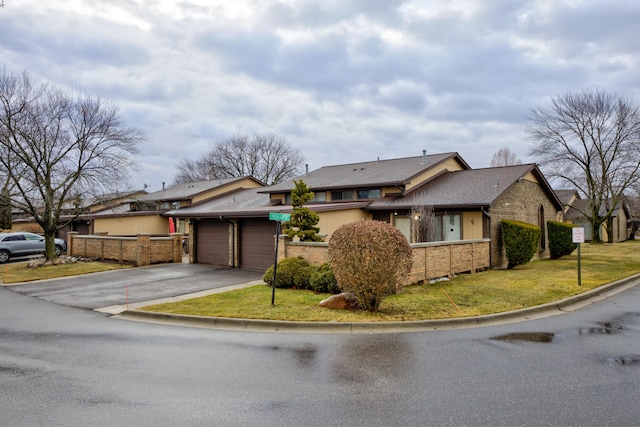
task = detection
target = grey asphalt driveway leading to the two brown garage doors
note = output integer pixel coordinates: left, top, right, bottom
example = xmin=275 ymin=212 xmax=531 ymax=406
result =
xmin=6 ymin=263 xmax=262 ymax=314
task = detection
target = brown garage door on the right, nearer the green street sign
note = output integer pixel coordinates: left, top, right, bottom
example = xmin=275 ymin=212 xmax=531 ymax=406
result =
xmin=240 ymin=218 xmax=276 ymax=271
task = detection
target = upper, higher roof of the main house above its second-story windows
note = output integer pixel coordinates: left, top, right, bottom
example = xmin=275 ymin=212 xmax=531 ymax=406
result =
xmin=261 ymin=153 xmax=471 ymax=193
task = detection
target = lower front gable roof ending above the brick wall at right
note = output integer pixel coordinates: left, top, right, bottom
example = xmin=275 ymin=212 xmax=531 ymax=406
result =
xmin=369 ymin=164 xmax=562 ymax=210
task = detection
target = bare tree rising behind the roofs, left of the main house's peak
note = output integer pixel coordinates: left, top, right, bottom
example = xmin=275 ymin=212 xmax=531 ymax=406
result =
xmin=174 ymin=133 xmax=304 ymax=185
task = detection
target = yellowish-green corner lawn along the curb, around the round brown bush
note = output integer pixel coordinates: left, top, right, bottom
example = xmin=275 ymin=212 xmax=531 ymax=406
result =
xmin=142 ymin=241 xmax=640 ymax=322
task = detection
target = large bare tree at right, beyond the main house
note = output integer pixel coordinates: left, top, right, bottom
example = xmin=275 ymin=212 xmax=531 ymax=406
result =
xmin=527 ymin=90 xmax=640 ymax=242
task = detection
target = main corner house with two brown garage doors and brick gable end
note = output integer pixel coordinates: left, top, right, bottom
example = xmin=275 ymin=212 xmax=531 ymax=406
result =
xmin=172 ymin=152 xmax=562 ymax=269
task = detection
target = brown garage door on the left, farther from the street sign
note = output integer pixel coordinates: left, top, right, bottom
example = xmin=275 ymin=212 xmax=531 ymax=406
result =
xmin=196 ymin=219 xmax=229 ymax=266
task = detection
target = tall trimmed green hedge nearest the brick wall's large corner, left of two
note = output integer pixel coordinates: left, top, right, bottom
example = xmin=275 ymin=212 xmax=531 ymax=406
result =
xmin=502 ymin=219 xmax=540 ymax=269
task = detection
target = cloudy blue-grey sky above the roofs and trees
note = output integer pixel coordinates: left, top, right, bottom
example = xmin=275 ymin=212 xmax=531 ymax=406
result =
xmin=0 ymin=0 xmax=640 ymax=191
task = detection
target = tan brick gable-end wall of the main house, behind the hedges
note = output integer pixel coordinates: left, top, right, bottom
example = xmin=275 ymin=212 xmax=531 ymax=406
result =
xmin=490 ymin=180 xmax=561 ymax=268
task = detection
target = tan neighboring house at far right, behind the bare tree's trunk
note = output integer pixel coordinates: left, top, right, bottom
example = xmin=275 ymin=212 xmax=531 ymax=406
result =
xmin=564 ymin=198 xmax=630 ymax=242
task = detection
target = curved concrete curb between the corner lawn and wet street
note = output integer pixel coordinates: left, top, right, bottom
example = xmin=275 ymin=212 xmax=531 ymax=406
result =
xmin=112 ymin=274 xmax=640 ymax=334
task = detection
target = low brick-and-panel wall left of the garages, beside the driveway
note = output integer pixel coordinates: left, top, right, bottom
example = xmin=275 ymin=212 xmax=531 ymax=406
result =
xmin=67 ymin=232 xmax=182 ymax=267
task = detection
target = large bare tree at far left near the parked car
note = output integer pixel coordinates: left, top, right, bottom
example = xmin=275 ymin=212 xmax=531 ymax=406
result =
xmin=0 ymin=67 xmax=144 ymax=259
